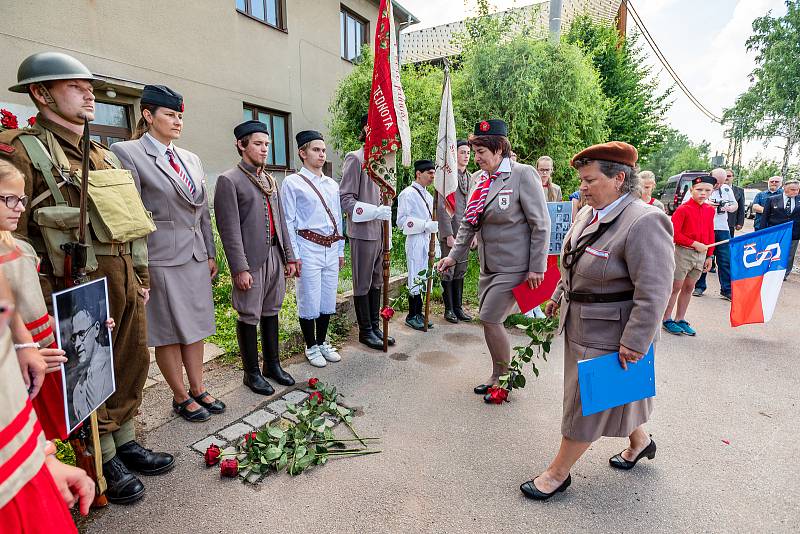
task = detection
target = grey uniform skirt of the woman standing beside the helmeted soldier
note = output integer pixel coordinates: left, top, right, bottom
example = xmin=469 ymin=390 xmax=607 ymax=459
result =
xmin=145 ymin=258 xmax=216 ymax=347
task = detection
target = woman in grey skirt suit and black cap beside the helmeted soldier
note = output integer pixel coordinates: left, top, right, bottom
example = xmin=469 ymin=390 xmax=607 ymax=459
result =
xmin=111 ymin=85 xmax=225 ymax=422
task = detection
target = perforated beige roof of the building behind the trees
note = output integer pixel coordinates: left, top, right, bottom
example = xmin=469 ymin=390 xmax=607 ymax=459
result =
xmin=404 ymin=0 xmax=620 ymax=63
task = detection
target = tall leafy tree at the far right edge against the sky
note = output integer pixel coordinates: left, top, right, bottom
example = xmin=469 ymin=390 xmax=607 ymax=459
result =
xmin=724 ymin=0 xmax=800 ymax=175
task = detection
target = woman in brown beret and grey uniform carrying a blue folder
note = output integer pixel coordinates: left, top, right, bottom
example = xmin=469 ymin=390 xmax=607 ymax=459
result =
xmin=520 ymin=141 xmax=675 ymax=500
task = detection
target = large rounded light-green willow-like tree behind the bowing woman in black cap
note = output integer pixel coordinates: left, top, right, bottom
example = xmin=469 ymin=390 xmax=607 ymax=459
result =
xmin=453 ymin=17 xmax=609 ymax=191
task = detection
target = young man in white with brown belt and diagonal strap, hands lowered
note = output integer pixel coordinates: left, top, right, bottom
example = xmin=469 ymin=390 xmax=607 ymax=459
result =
xmin=281 ymin=130 xmax=344 ymax=367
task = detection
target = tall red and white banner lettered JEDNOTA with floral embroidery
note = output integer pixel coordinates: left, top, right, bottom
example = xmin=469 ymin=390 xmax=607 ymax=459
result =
xmin=364 ymin=0 xmax=411 ymax=198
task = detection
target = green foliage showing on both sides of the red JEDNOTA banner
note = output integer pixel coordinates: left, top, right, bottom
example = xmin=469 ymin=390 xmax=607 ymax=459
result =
xmin=328 ymin=48 xmax=446 ymax=193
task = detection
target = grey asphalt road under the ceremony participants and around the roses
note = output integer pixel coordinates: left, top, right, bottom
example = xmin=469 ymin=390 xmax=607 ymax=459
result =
xmin=86 ymin=242 xmax=800 ymax=533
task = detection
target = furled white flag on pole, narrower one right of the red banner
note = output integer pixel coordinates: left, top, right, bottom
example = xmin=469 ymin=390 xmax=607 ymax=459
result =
xmin=433 ymin=65 xmax=458 ymax=217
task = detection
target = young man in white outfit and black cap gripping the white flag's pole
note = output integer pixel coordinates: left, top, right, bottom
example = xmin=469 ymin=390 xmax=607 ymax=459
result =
xmin=397 ymin=159 xmax=441 ymax=330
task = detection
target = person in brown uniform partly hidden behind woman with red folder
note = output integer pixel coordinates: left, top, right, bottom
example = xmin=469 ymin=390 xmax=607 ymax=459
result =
xmin=436 ymin=139 xmax=477 ymax=323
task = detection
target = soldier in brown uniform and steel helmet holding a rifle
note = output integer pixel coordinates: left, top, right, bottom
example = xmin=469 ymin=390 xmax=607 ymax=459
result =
xmin=0 ymin=52 xmax=174 ymax=503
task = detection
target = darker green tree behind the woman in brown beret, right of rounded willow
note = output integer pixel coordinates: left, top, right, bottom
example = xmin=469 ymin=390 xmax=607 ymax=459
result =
xmin=564 ymin=15 xmax=672 ymax=161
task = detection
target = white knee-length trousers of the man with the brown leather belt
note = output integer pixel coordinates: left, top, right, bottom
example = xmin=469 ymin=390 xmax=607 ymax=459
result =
xmin=295 ymin=236 xmax=339 ymax=319
